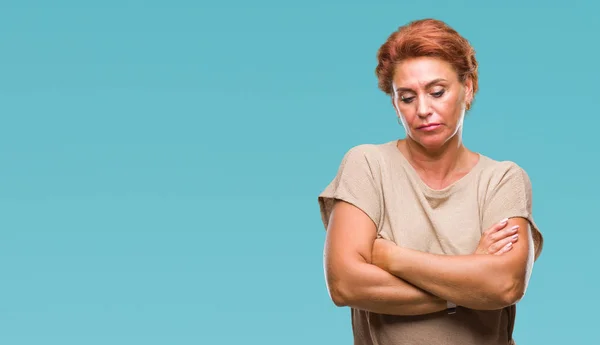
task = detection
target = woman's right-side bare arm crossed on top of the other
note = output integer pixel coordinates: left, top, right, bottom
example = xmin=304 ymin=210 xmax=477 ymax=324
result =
xmin=373 ymin=218 xmax=534 ymax=310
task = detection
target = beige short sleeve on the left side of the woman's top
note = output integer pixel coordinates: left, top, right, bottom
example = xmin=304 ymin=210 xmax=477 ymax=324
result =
xmin=318 ymin=144 xmax=382 ymax=229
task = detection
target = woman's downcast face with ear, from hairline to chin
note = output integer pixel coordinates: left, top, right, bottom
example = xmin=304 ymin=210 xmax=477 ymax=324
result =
xmin=392 ymin=57 xmax=472 ymax=150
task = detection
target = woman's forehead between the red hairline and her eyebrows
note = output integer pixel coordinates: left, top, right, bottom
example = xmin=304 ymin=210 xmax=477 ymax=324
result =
xmin=393 ymin=57 xmax=458 ymax=88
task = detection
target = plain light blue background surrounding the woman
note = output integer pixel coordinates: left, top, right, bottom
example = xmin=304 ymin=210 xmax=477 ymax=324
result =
xmin=0 ymin=0 xmax=600 ymax=345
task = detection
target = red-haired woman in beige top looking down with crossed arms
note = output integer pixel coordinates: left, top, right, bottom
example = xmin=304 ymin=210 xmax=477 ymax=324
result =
xmin=319 ymin=19 xmax=543 ymax=345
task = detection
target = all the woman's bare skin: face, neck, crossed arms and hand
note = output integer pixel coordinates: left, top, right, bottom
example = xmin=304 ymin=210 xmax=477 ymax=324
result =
xmin=324 ymin=57 xmax=534 ymax=315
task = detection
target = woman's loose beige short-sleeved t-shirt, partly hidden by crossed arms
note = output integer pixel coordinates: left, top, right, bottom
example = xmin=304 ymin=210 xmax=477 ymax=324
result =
xmin=318 ymin=140 xmax=543 ymax=345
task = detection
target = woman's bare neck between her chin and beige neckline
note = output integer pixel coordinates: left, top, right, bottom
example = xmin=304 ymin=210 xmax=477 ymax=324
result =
xmin=404 ymin=133 xmax=468 ymax=182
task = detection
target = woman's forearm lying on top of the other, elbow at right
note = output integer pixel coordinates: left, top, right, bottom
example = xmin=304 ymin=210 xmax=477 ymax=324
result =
xmin=388 ymin=247 xmax=522 ymax=310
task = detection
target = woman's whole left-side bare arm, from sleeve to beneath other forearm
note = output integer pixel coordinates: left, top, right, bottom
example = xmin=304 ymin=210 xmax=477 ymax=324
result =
xmin=324 ymin=201 xmax=446 ymax=315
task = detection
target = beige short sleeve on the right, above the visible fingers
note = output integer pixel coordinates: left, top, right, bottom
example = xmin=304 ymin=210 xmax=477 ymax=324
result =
xmin=482 ymin=162 xmax=543 ymax=259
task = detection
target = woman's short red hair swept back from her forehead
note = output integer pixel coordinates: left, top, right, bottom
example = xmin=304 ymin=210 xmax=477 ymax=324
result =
xmin=375 ymin=19 xmax=478 ymax=109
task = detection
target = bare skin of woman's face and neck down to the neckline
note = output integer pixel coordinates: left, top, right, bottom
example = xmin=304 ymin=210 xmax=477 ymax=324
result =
xmin=392 ymin=57 xmax=479 ymax=189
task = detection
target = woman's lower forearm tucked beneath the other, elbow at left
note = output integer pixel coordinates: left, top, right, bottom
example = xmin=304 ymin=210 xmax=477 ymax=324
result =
xmin=331 ymin=262 xmax=446 ymax=315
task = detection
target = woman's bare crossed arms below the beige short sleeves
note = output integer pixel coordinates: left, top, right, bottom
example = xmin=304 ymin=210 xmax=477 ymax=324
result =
xmin=324 ymin=201 xmax=535 ymax=315
